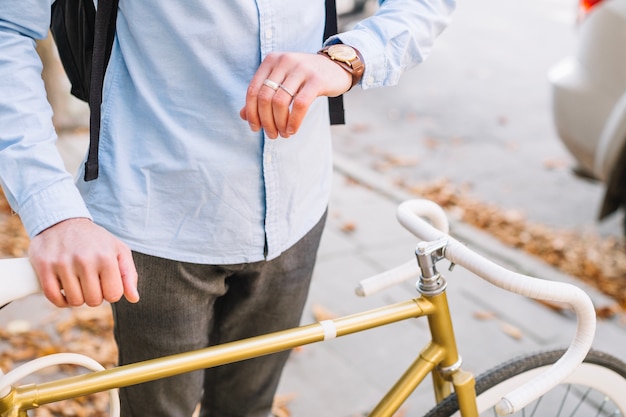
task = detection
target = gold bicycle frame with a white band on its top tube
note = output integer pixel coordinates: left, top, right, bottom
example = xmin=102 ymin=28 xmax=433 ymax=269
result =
xmin=0 ymin=280 xmax=478 ymax=417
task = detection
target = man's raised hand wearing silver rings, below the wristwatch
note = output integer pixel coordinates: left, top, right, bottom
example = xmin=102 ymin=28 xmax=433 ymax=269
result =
xmin=239 ymin=52 xmax=352 ymax=139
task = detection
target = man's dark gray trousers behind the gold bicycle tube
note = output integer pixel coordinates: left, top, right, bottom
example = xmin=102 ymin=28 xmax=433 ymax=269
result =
xmin=113 ymin=216 xmax=325 ymax=417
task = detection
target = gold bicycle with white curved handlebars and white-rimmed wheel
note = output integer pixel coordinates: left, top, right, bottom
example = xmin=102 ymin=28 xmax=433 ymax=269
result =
xmin=0 ymin=200 xmax=626 ymax=417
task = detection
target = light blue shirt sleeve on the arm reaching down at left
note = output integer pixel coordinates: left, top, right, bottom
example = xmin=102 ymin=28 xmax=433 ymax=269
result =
xmin=0 ymin=8 xmax=89 ymax=237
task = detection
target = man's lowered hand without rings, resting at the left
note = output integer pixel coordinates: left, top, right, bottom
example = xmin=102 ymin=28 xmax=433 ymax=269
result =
xmin=28 ymin=218 xmax=139 ymax=307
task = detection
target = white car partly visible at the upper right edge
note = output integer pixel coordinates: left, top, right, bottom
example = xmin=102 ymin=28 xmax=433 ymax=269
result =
xmin=548 ymin=0 xmax=626 ymax=229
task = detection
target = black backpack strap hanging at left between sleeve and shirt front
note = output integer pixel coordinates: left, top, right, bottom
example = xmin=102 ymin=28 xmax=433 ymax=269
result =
xmin=85 ymin=0 xmax=118 ymax=181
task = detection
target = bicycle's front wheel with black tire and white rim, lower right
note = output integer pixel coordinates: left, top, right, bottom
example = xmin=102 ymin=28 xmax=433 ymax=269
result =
xmin=425 ymin=350 xmax=626 ymax=417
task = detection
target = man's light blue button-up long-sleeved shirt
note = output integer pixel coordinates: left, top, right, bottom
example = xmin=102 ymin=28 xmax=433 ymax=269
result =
xmin=0 ymin=0 xmax=454 ymax=264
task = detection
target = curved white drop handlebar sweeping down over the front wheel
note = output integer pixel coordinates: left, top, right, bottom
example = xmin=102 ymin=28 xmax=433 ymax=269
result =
xmin=397 ymin=200 xmax=596 ymax=415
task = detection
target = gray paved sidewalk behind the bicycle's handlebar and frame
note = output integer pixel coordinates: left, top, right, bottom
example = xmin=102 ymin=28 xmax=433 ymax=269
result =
xmin=279 ymin=155 xmax=626 ymax=417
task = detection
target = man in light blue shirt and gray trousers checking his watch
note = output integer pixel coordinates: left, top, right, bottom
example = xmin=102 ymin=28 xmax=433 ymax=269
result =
xmin=0 ymin=0 xmax=454 ymax=417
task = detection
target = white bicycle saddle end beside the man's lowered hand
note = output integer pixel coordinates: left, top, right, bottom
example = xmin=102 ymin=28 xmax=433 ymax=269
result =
xmin=0 ymin=258 xmax=41 ymax=306
